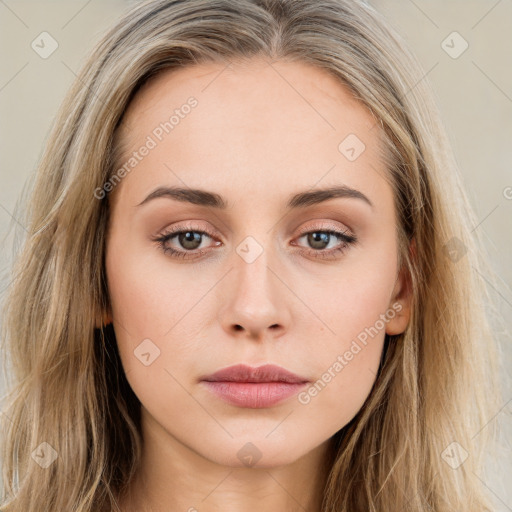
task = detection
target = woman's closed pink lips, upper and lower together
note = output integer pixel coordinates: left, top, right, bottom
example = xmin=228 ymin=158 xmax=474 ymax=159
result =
xmin=201 ymin=364 xmax=309 ymax=409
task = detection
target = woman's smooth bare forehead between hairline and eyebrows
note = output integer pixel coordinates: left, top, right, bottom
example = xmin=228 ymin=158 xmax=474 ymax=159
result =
xmin=112 ymin=58 xmax=390 ymax=212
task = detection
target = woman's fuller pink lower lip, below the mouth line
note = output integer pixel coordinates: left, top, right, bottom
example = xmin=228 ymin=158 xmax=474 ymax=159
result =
xmin=203 ymin=381 xmax=308 ymax=409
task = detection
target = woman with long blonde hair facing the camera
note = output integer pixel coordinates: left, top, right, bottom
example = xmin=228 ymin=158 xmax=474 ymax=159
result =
xmin=0 ymin=0 xmax=499 ymax=512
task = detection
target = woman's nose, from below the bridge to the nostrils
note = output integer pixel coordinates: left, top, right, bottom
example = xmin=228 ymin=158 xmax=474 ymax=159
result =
xmin=219 ymin=243 xmax=291 ymax=340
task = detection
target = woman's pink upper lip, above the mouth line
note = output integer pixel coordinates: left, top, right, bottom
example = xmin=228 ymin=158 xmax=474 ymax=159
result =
xmin=201 ymin=364 xmax=309 ymax=384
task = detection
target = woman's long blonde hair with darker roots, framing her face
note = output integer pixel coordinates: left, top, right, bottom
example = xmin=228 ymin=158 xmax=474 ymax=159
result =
xmin=0 ymin=0 xmax=500 ymax=512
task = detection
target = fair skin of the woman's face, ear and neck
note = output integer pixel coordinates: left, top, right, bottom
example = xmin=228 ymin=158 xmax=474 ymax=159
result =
xmin=104 ymin=58 xmax=410 ymax=512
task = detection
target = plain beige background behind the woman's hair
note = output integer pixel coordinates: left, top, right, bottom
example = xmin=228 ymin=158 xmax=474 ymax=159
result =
xmin=0 ymin=0 xmax=512 ymax=511
